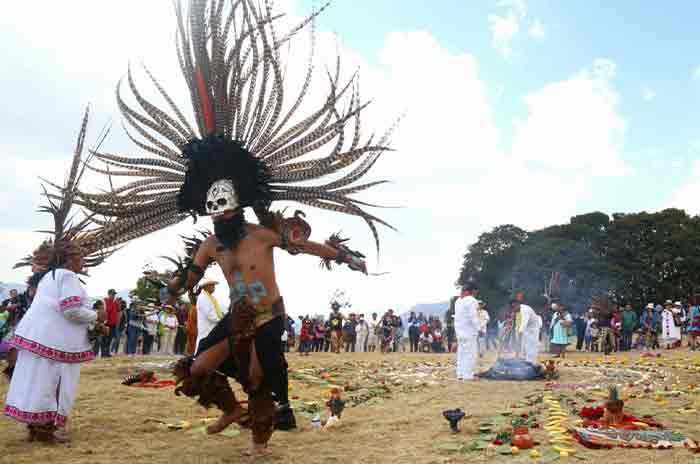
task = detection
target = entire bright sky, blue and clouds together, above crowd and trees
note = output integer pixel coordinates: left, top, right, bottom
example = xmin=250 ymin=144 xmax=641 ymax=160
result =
xmin=0 ymin=0 xmax=700 ymax=312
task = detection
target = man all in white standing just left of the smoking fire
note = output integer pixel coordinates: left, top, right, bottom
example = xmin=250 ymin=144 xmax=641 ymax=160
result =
xmin=455 ymin=283 xmax=479 ymax=380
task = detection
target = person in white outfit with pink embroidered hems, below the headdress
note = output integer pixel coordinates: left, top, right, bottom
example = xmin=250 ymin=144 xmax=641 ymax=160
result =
xmin=4 ymin=244 xmax=107 ymax=442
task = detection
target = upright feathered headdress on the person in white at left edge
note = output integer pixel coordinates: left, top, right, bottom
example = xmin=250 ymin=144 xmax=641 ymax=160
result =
xmin=15 ymin=108 xmax=110 ymax=278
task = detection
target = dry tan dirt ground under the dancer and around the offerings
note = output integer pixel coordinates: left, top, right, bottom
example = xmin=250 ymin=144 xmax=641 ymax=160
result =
xmin=0 ymin=350 xmax=700 ymax=464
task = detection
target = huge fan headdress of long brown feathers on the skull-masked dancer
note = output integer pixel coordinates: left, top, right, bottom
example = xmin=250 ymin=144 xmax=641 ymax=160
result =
xmin=76 ymin=0 xmax=393 ymax=254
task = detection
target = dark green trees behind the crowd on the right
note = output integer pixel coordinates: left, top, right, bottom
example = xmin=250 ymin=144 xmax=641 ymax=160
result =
xmin=457 ymin=209 xmax=700 ymax=311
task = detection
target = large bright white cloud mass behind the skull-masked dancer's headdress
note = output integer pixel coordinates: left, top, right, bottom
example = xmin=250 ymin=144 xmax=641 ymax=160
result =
xmin=0 ymin=1 xmax=624 ymax=314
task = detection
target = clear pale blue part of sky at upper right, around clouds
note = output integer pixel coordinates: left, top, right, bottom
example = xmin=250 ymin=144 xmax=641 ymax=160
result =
xmin=302 ymin=0 xmax=700 ymax=211
